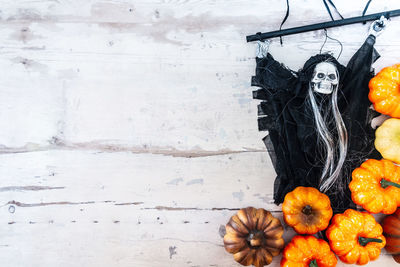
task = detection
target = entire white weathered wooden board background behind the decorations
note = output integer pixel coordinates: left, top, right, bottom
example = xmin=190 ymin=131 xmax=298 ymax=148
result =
xmin=0 ymin=0 xmax=400 ymax=267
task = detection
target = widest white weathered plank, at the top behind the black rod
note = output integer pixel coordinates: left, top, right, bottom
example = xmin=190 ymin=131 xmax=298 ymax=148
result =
xmin=0 ymin=0 xmax=400 ymax=153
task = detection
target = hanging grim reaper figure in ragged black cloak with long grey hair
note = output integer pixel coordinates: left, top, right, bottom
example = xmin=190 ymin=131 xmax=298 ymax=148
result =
xmin=252 ymin=17 xmax=384 ymax=212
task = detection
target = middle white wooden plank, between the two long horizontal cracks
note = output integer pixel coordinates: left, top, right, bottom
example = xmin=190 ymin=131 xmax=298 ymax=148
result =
xmin=0 ymin=150 xmax=279 ymax=210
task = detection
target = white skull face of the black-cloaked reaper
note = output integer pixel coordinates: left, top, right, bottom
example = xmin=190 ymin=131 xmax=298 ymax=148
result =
xmin=311 ymin=62 xmax=339 ymax=94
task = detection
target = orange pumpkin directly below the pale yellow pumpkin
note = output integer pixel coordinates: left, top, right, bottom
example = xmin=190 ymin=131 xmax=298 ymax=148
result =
xmin=349 ymin=159 xmax=400 ymax=214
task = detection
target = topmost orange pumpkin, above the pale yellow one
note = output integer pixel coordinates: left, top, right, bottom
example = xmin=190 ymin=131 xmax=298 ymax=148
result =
xmin=368 ymin=64 xmax=400 ymax=118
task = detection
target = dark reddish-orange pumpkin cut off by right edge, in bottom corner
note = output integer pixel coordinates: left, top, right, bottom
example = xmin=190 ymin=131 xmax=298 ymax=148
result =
xmin=382 ymin=208 xmax=400 ymax=263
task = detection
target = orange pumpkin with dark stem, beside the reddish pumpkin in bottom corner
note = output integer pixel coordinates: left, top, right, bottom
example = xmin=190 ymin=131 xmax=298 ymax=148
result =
xmin=326 ymin=209 xmax=386 ymax=265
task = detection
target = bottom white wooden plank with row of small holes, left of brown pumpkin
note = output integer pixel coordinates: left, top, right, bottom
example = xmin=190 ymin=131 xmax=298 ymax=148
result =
xmin=0 ymin=208 xmax=288 ymax=266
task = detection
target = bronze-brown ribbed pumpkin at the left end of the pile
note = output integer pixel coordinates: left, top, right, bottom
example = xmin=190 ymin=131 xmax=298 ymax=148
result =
xmin=224 ymin=207 xmax=285 ymax=267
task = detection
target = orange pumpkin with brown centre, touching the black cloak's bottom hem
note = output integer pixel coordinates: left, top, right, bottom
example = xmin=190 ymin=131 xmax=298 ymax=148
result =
xmin=282 ymin=186 xmax=333 ymax=235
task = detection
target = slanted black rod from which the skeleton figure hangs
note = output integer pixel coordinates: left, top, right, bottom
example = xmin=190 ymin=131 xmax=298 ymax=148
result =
xmin=246 ymin=9 xmax=400 ymax=42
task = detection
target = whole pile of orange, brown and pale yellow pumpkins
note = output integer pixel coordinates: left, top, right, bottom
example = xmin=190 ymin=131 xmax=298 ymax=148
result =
xmin=224 ymin=64 xmax=400 ymax=267
